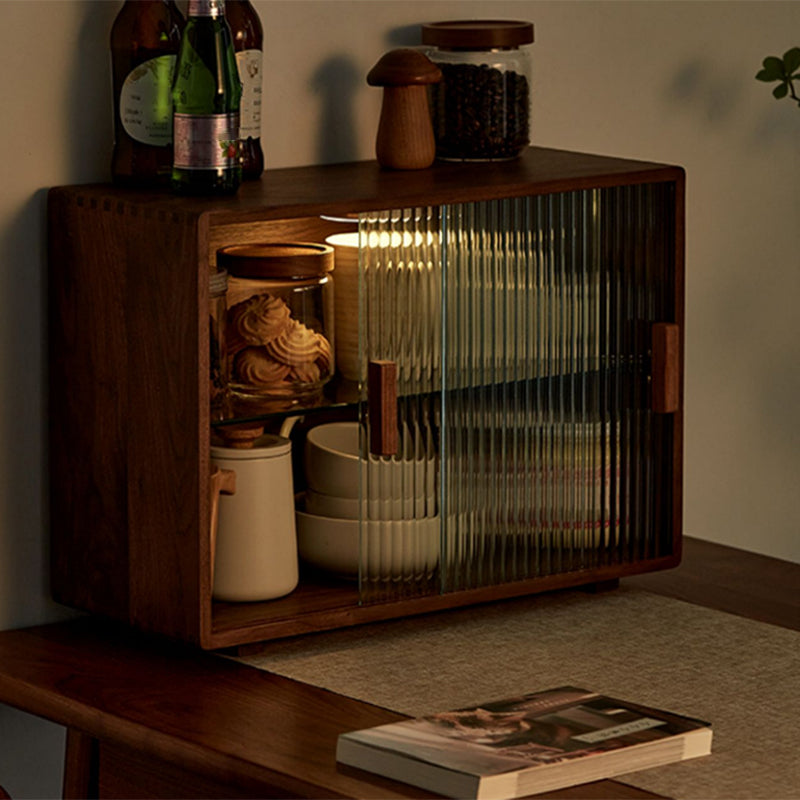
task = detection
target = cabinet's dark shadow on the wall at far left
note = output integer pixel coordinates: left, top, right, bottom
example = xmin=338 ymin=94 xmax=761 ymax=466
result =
xmin=0 ymin=189 xmax=76 ymax=628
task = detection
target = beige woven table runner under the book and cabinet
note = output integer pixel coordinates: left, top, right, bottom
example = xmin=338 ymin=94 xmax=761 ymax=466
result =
xmin=236 ymin=586 xmax=800 ymax=800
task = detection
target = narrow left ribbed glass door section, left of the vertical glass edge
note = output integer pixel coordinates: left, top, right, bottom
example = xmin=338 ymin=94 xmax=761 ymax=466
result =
xmin=358 ymin=208 xmax=442 ymax=601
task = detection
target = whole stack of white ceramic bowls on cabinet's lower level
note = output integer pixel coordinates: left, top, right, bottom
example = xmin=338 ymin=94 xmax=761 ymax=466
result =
xmin=297 ymin=422 xmax=439 ymax=581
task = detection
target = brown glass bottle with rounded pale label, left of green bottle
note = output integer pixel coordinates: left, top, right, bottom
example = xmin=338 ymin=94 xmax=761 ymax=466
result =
xmin=111 ymin=0 xmax=184 ymax=186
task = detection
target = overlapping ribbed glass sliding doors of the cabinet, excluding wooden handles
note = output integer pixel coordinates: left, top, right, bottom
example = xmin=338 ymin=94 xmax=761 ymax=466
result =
xmin=359 ymin=184 xmax=675 ymax=601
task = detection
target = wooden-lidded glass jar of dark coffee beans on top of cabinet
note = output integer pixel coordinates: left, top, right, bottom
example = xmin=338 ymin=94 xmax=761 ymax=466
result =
xmin=422 ymin=20 xmax=533 ymax=161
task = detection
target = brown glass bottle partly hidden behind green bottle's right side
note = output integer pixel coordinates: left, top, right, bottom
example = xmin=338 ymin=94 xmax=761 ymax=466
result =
xmin=225 ymin=0 xmax=264 ymax=180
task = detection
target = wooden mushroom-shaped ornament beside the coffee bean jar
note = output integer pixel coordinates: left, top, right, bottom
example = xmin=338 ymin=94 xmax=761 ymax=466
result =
xmin=367 ymin=48 xmax=442 ymax=169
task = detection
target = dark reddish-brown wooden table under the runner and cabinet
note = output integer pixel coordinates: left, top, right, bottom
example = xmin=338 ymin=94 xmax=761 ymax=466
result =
xmin=0 ymin=539 xmax=800 ymax=798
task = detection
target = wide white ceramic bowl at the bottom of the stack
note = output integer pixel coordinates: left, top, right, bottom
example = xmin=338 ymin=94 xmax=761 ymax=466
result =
xmin=296 ymin=511 xmax=439 ymax=580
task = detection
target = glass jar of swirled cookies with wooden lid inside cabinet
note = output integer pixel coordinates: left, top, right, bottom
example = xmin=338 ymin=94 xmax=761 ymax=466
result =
xmin=217 ymin=242 xmax=334 ymax=406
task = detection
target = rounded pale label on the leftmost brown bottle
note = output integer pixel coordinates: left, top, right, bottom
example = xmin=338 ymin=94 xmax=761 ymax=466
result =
xmin=119 ymin=54 xmax=177 ymax=147
